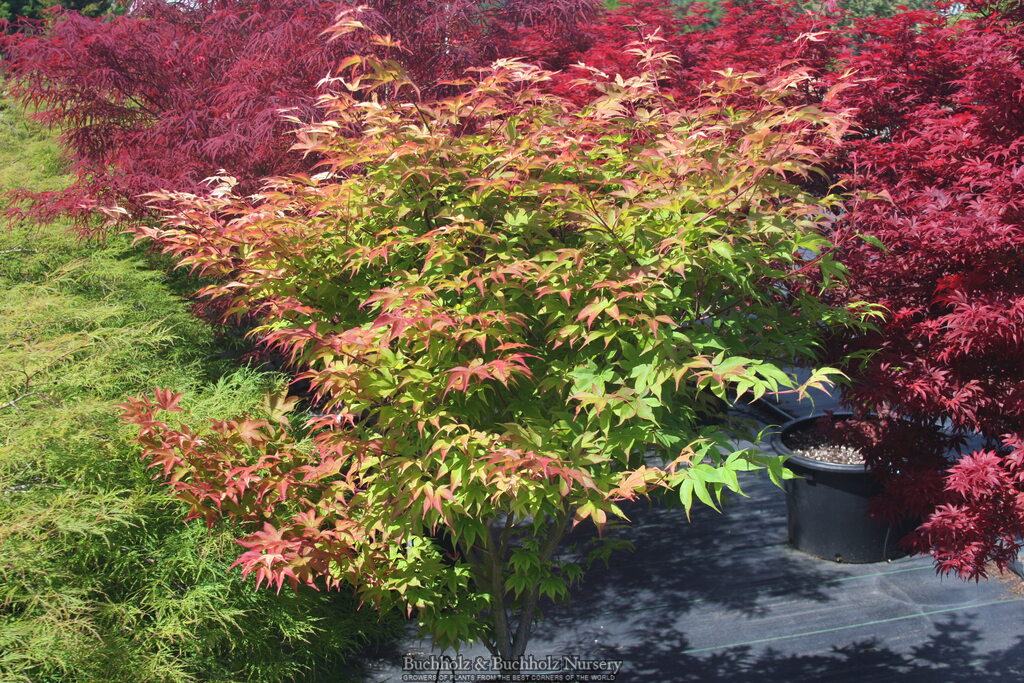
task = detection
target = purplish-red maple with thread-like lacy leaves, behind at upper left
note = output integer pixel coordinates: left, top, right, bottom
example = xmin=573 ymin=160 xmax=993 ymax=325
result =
xmin=0 ymin=0 xmax=594 ymax=225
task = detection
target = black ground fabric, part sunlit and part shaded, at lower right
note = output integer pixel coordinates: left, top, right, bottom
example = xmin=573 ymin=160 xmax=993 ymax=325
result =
xmin=356 ymin=471 xmax=1024 ymax=683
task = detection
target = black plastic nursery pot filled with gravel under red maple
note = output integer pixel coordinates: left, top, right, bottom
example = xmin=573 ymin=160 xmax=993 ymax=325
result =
xmin=773 ymin=413 xmax=915 ymax=563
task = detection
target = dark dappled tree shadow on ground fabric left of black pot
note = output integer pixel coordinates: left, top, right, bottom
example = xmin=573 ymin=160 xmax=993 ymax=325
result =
xmin=535 ymin=479 xmax=854 ymax=637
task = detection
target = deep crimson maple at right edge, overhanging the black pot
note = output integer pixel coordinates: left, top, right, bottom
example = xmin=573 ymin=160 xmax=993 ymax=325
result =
xmin=823 ymin=12 xmax=1024 ymax=578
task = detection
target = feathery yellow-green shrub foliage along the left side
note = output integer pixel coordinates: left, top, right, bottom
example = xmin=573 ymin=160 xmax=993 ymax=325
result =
xmin=0 ymin=101 xmax=393 ymax=681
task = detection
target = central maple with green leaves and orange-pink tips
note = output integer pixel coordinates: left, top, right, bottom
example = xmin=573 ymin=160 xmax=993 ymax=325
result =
xmin=123 ymin=29 xmax=859 ymax=663
